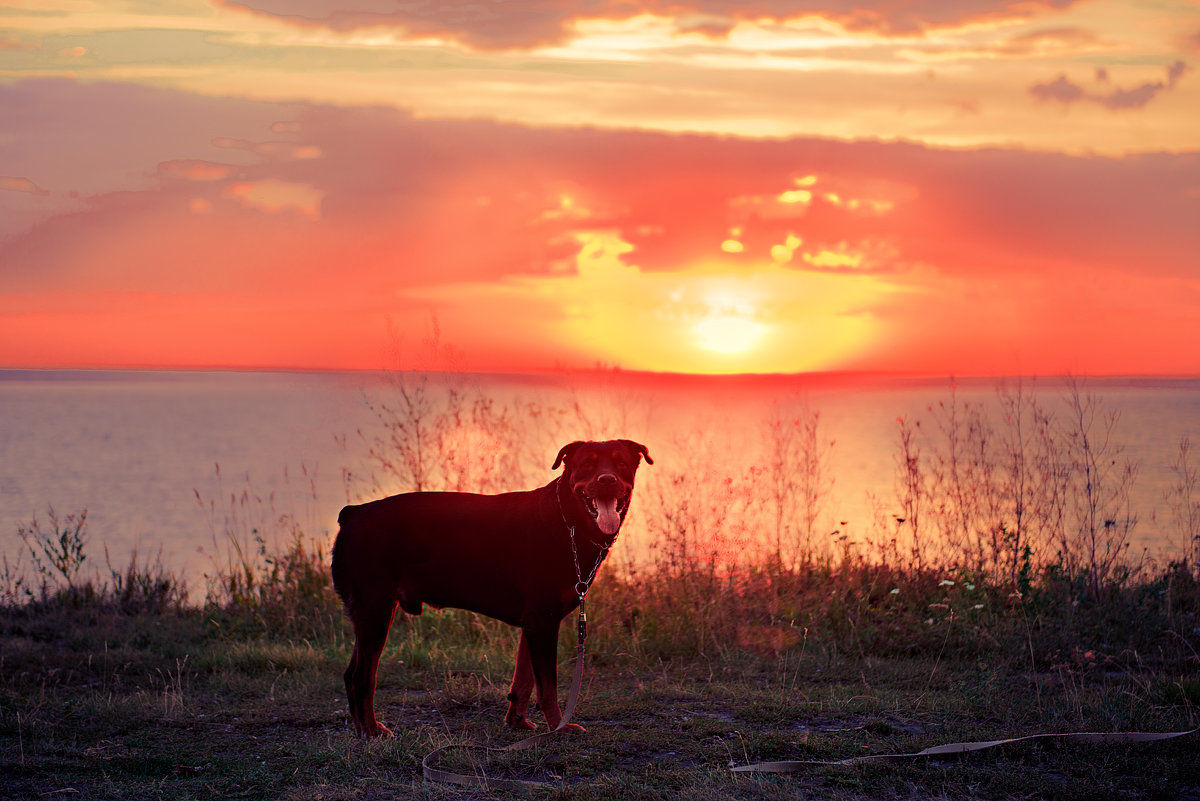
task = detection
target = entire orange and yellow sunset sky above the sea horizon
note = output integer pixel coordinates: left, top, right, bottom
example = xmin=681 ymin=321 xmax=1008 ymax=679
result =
xmin=0 ymin=0 xmax=1200 ymax=375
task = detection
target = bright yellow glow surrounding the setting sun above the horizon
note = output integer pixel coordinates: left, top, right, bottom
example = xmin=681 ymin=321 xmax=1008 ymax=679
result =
xmin=406 ymin=231 xmax=898 ymax=374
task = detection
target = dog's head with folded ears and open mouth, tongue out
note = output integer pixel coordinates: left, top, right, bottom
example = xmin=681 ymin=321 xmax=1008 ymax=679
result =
xmin=551 ymin=439 xmax=654 ymax=537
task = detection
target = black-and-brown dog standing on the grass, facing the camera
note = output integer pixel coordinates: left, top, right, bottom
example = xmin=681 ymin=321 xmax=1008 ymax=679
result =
xmin=332 ymin=439 xmax=654 ymax=739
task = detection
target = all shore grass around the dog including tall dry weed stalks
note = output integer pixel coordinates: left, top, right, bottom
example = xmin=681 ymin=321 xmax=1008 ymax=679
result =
xmin=7 ymin=376 xmax=1200 ymax=801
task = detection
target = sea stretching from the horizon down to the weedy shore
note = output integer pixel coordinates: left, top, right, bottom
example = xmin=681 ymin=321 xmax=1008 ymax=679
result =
xmin=0 ymin=369 xmax=1200 ymax=597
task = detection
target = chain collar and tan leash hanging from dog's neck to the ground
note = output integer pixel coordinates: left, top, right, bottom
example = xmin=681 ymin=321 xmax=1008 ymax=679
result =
xmin=421 ymin=476 xmax=617 ymax=789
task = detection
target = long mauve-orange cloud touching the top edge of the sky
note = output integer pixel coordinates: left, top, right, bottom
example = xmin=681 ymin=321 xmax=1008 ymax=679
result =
xmin=218 ymin=0 xmax=1078 ymax=49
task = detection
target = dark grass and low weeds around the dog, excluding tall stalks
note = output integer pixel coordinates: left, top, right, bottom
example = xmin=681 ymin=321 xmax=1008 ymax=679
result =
xmin=0 ymin=527 xmax=1200 ymax=801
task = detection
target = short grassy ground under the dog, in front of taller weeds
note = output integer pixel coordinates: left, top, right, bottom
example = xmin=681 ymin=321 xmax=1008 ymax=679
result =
xmin=0 ymin=588 xmax=1200 ymax=801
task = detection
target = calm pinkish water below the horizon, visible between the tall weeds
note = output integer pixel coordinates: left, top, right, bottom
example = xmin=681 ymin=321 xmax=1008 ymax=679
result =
xmin=0 ymin=371 xmax=1200 ymax=595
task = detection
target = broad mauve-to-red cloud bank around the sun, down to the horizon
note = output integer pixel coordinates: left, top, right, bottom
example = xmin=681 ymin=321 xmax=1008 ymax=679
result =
xmin=0 ymin=83 xmax=1200 ymax=374
